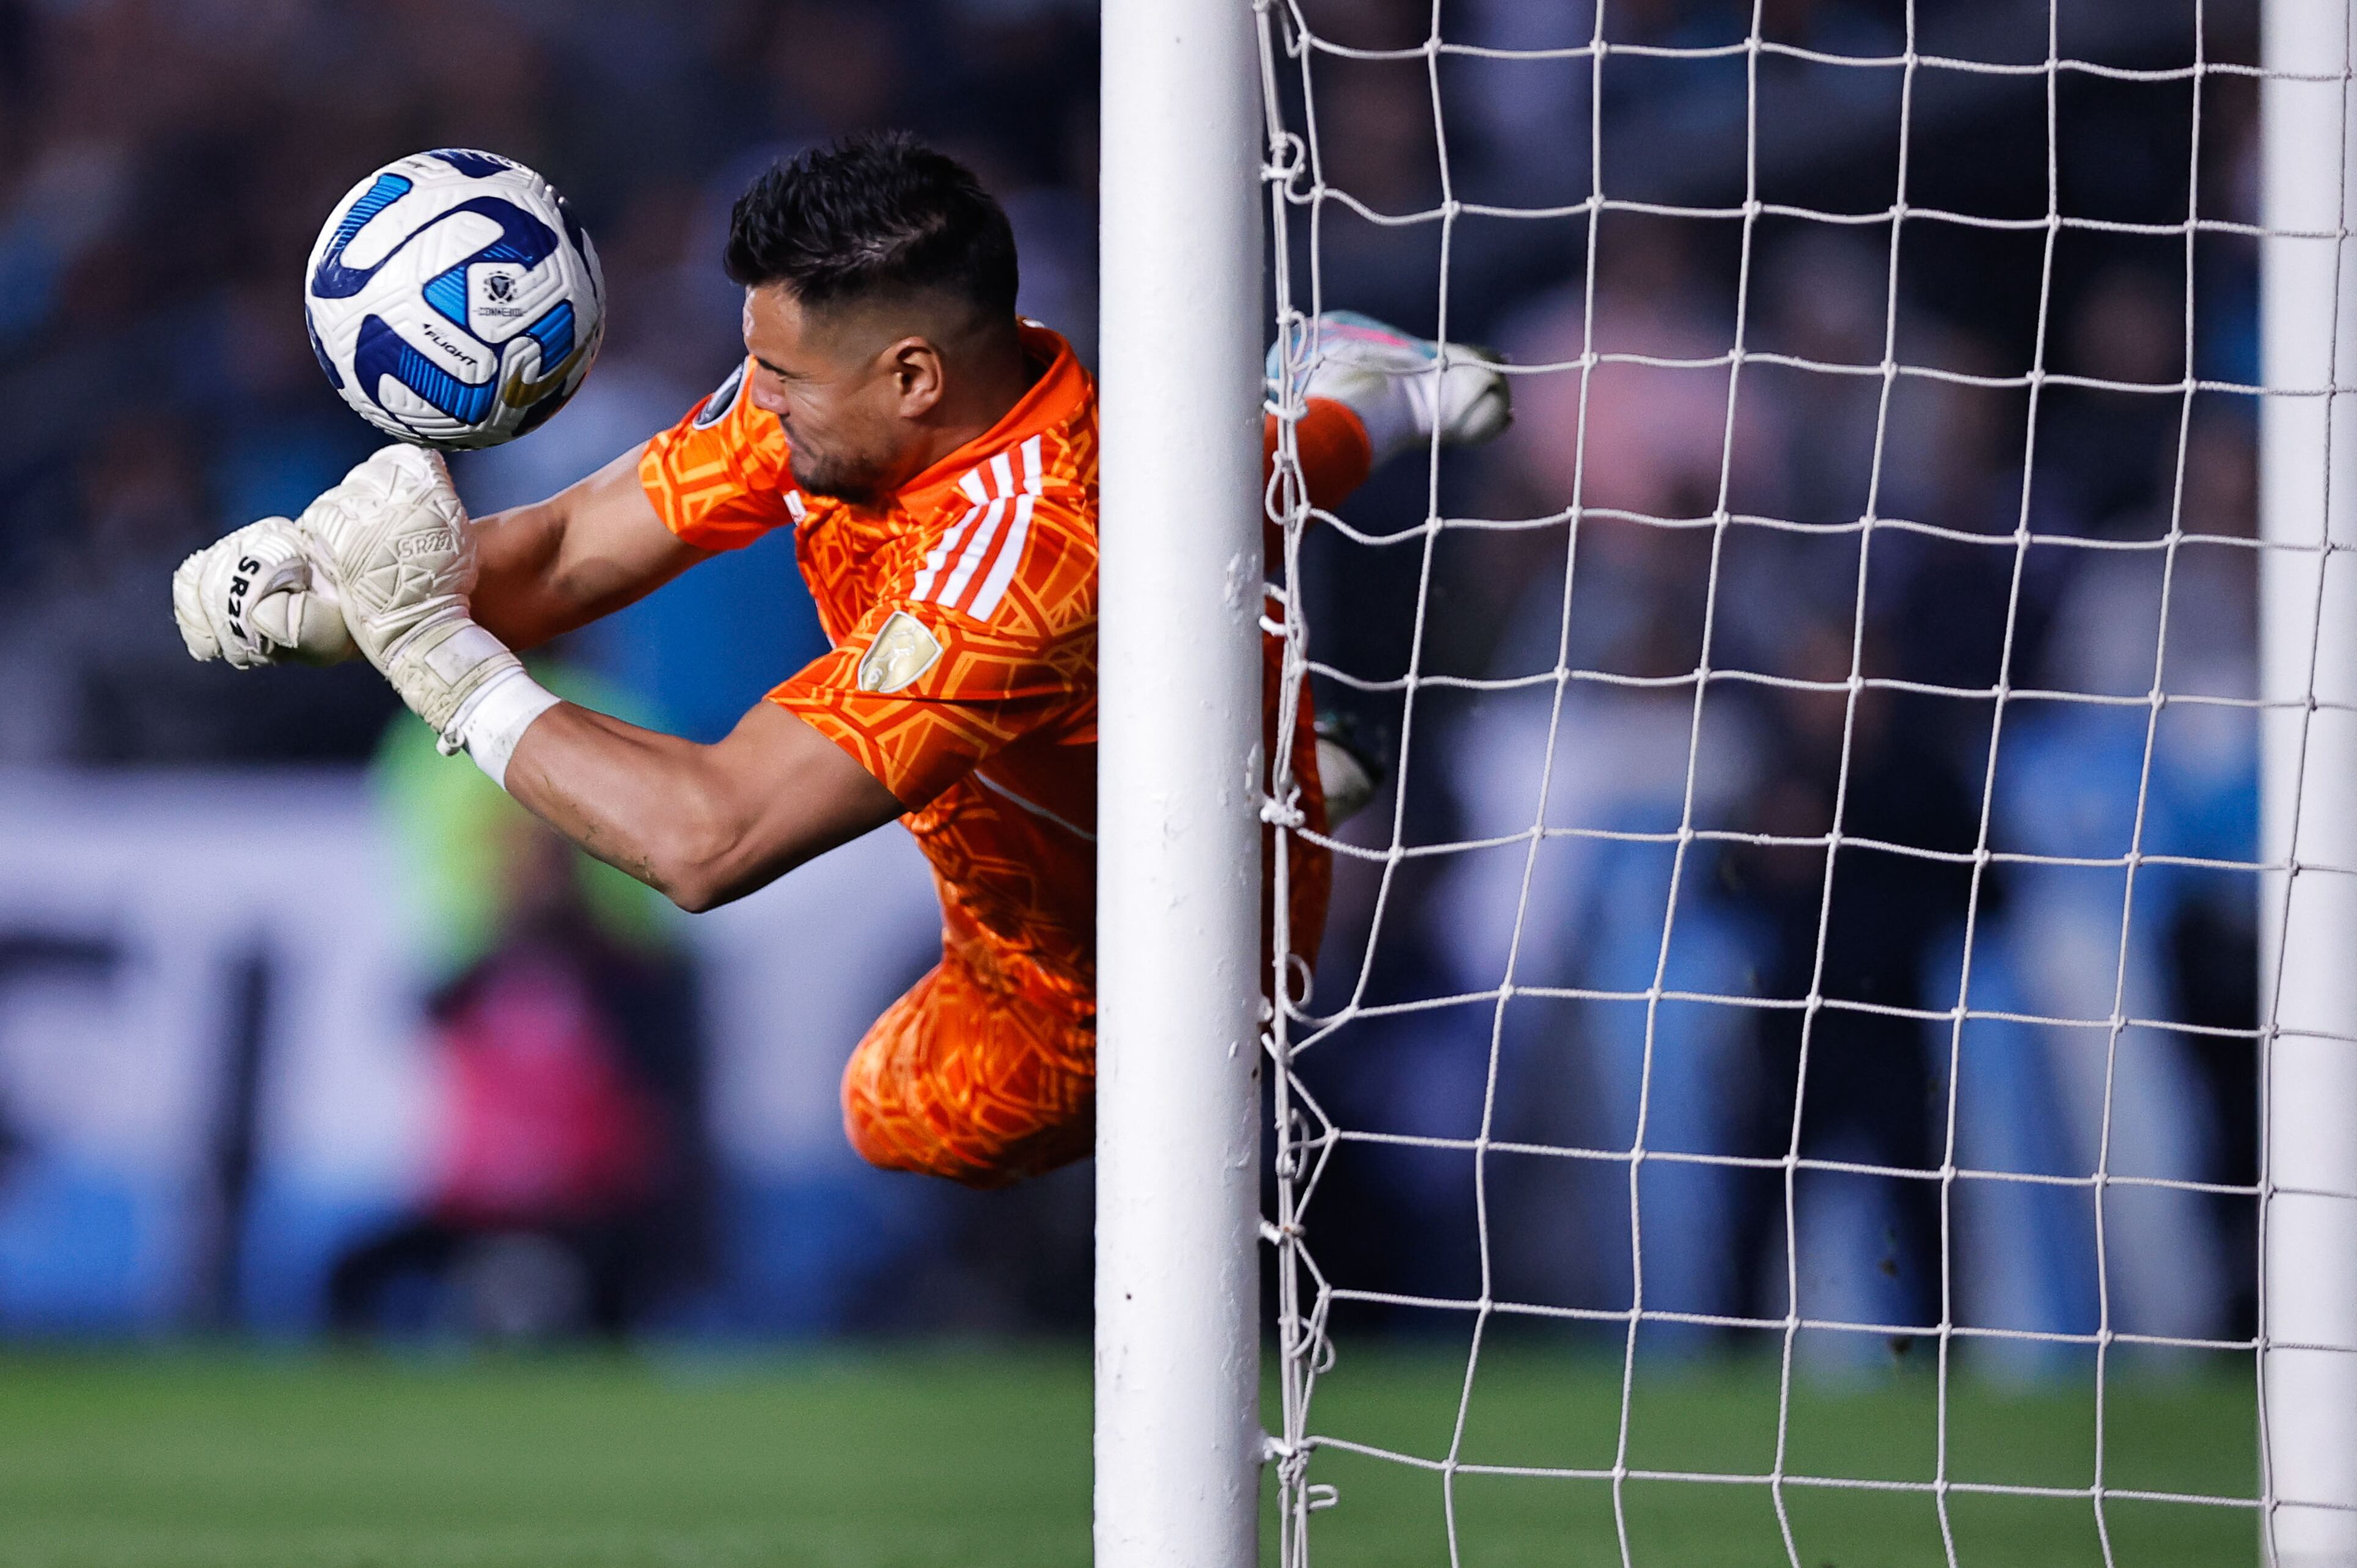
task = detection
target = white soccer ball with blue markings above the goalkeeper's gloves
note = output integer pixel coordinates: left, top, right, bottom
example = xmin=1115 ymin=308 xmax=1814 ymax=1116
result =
xmin=304 ymin=146 xmax=606 ymax=448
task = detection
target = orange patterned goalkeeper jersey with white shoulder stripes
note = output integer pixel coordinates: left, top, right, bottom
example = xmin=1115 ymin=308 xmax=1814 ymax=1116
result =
xmin=639 ymin=323 xmax=1096 ymax=1009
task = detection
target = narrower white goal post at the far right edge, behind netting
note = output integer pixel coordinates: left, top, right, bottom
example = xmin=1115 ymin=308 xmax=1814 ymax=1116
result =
xmin=2260 ymin=0 xmax=2357 ymax=1568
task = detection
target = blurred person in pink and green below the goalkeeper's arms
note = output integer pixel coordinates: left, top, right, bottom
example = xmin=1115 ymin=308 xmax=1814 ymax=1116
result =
xmin=328 ymin=693 xmax=712 ymax=1337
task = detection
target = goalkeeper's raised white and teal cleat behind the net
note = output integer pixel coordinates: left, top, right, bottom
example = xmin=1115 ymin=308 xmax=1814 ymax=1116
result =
xmin=1268 ymin=311 xmax=1513 ymax=462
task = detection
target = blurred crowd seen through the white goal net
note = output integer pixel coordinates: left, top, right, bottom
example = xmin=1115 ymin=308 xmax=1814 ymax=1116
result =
xmin=1287 ymin=2 xmax=2258 ymax=1370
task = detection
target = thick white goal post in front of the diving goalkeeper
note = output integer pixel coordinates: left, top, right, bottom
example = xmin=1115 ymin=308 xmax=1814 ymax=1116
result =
xmin=1096 ymin=0 xmax=1261 ymax=1568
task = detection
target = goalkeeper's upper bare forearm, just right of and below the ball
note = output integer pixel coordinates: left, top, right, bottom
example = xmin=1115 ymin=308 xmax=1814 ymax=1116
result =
xmin=471 ymin=443 xmax=712 ymax=648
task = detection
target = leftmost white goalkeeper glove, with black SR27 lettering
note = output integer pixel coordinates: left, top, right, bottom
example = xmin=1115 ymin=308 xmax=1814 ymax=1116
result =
xmin=172 ymin=516 xmax=358 ymax=670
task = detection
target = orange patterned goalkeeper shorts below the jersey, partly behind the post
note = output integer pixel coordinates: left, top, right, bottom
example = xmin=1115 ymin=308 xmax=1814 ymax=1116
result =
xmin=844 ymin=639 xmax=1334 ymax=1186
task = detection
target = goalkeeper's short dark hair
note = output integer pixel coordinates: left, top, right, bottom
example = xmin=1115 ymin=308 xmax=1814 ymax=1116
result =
xmin=721 ymin=132 xmax=1016 ymax=318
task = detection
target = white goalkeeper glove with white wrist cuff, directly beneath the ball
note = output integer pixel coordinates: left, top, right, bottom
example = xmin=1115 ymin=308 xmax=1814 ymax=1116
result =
xmin=297 ymin=443 xmax=556 ymax=785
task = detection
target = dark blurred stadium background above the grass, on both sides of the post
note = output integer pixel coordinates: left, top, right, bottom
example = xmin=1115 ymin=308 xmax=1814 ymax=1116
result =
xmin=0 ymin=0 xmax=2258 ymax=1370
